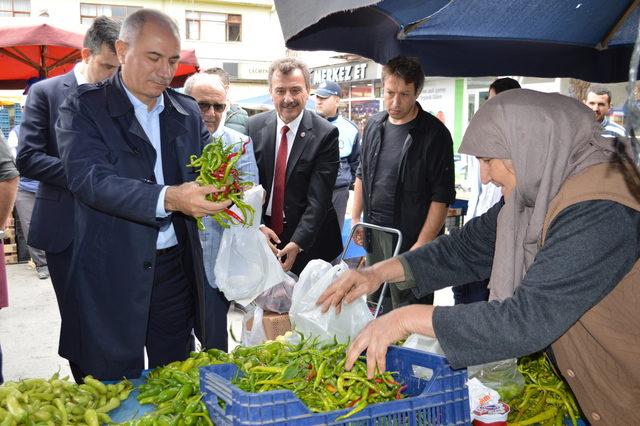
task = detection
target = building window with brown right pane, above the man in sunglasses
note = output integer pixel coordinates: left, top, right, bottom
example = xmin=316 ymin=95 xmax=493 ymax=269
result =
xmin=186 ymin=10 xmax=242 ymax=41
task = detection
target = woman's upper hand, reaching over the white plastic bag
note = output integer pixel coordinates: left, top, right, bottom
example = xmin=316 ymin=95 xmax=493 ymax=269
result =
xmin=316 ymin=268 xmax=383 ymax=314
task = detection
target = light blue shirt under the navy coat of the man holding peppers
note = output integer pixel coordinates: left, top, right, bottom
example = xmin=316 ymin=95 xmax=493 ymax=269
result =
xmin=122 ymin=82 xmax=178 ymax=250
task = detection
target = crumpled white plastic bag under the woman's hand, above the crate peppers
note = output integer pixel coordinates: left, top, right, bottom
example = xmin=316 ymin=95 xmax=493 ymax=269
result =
xmin=289 ymin=259 xmax=373 ymax=343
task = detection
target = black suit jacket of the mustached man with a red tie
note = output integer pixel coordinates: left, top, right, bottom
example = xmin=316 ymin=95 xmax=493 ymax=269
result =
xmin=247 ymin=110 xmax=342 ymax=273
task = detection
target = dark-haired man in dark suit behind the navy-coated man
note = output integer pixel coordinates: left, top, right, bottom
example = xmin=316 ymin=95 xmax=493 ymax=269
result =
xmin=16 ymin=16 xmax=120 ymax=315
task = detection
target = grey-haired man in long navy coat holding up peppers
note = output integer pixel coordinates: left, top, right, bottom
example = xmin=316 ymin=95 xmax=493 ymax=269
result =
xmin=56 ymin=9 xmax=230 ymax=380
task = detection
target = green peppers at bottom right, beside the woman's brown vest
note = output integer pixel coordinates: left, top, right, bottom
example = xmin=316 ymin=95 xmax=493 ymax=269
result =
xmin=507 ymin=353 xmax=580 ymax=426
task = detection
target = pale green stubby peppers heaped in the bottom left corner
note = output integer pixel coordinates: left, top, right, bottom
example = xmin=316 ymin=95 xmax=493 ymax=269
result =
xmin=0 ymin=373 xmax=132 ymax=426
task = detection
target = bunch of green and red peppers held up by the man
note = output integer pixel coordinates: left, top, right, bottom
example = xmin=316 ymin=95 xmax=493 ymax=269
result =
xmin=187 ymin=137 xmax=255 ymax=230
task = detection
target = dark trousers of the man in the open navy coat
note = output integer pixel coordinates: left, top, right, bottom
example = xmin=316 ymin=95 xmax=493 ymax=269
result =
xmin=69 ymin=246 xmax=195 ymax=383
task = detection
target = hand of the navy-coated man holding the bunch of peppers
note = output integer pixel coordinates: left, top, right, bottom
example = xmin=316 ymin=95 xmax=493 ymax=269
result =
xmin=164 ymin=182 xmax=231 ymax=217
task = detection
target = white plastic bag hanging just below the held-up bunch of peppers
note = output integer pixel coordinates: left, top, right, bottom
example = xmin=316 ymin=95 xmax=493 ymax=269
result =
xmin=213 ymin=185 xmax=287 ymax=306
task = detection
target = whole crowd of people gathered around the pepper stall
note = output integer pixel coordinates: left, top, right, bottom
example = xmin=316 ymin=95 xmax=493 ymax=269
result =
xmin=0 ymin=5 xmax=640 ymax=424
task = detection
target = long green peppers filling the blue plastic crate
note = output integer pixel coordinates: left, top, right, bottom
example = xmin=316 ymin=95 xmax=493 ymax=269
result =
xmin=232 ymin=338 xmax=406 ymax=420
